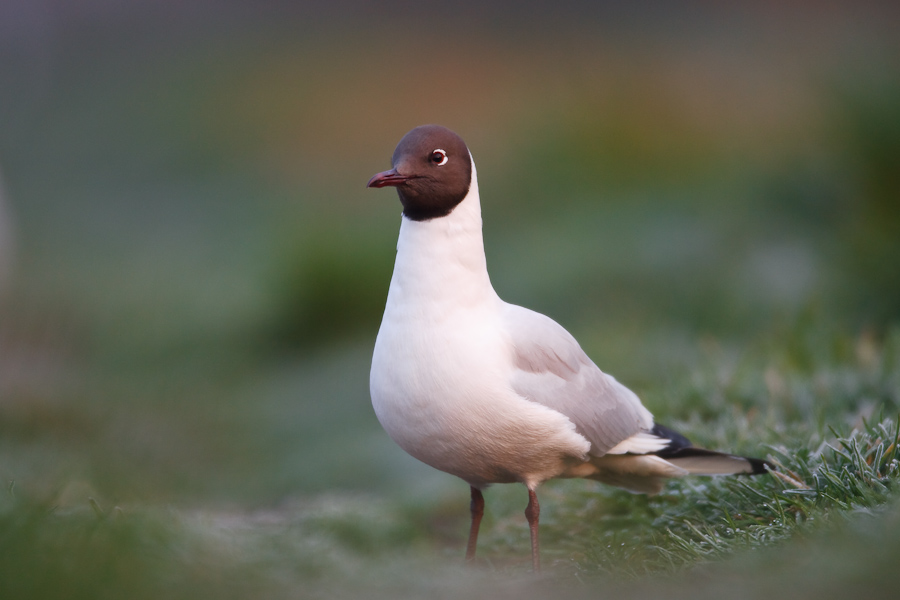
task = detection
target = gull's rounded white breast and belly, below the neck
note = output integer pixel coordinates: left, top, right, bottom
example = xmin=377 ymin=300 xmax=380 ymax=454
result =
xmin=370 ymin=304 xmax=590 ymax=487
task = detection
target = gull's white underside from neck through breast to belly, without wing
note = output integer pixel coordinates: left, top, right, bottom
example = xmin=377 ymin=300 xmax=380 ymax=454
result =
xmin=370 ymin=173 xmax=590 ymax=487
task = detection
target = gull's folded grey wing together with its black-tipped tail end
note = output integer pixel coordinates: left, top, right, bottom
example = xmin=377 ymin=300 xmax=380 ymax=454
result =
xmin=504 ymin=305 xmax=770 ymax=493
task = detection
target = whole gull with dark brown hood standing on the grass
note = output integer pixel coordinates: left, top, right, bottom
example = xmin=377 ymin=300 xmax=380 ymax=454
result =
xmin=367 ymin=125 xmax=769 ymax=571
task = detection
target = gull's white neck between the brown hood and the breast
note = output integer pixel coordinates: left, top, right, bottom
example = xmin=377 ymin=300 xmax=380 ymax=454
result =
xmin=388 ymin=164 xmax=496 ymax=312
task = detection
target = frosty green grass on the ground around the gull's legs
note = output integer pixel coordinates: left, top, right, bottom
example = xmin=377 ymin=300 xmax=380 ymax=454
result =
xmin=0 ymin=324 xmax=900 ymax=598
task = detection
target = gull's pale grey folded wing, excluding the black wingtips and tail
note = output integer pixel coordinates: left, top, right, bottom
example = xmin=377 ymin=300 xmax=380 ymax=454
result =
xmin=503 ymin=304 xmax=653 ymax=456
